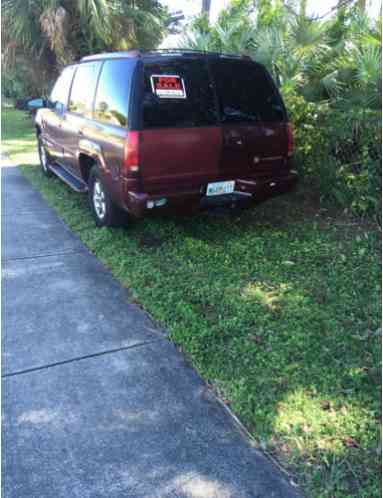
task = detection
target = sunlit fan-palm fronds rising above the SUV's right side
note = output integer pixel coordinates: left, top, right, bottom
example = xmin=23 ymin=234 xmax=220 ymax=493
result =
xmin=182 ymin=0 xmax=381 ymax=108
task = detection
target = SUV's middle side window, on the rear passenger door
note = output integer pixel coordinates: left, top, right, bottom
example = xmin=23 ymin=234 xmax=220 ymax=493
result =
xmin=69 ymin=62 xmax=101 ymax=117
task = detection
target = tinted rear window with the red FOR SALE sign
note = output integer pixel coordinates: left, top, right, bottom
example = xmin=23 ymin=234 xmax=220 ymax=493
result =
xmin=143 ymin=59 xmax=217 ymax=128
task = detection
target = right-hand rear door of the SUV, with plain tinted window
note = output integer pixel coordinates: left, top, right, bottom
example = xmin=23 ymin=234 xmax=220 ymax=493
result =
xmin=211 ymin=58 xmax=287 ymax=178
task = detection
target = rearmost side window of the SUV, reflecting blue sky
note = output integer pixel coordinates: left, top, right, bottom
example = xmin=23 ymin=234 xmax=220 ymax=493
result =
xmin=94 ymin=59 xmax=136 ymax=127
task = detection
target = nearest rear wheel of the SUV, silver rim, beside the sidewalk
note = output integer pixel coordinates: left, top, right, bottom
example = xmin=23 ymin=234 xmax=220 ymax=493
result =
xmin=88 ymin=165 xmax=123 ymax=227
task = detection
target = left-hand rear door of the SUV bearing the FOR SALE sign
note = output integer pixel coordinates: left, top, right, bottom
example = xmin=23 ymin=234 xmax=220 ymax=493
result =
xmin=140 ymin=58 xmax=222 ymax=191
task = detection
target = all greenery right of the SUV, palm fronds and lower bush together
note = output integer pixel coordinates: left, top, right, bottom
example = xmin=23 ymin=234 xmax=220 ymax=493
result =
xmin=182 ymin=0 xmax=382 ymax=218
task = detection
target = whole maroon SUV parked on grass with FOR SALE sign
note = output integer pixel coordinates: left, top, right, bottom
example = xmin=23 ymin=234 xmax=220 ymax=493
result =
xmin=36 ymin=50 xmax=297 ymax=226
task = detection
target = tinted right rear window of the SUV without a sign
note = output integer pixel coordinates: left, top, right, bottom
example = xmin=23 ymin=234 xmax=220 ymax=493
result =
xmin=212 ymin=60 xmax=286 ymax=123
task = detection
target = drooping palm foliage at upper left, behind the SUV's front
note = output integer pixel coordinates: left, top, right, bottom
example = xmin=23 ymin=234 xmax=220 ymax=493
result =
xmin=2 ymin=0 xmax=169 ymax=92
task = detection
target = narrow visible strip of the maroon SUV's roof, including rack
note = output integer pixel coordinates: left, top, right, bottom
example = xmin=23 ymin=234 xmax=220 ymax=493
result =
xmin=80 ymin=48 xmax=252 ymax=62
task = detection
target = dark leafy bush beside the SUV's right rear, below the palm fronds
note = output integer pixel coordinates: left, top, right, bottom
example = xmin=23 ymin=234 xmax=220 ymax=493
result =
xmin=284 ymin=92 xmax=382 ymax=219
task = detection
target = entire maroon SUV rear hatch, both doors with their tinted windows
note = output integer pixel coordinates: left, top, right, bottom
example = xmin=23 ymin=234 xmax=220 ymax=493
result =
xmin=140 ymin=56 xmax=288 ymax=193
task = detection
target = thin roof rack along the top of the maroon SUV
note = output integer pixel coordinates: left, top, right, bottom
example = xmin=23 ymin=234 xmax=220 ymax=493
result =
xmin=81 ymin=48 xmax=251 ymax=62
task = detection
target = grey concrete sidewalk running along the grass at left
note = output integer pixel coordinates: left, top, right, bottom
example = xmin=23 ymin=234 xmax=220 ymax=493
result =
xmin=2 ymin=168 xmax=299 ymax=498
